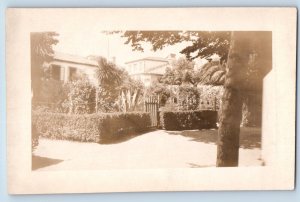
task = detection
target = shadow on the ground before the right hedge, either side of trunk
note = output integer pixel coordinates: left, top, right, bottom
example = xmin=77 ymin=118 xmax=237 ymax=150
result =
xmin=166 ymin=127 xmax=261 ymax=149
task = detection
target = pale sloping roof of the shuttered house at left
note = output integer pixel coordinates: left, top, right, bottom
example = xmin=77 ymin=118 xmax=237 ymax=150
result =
xmin=54 ymin=52 xmax=98 ymax=66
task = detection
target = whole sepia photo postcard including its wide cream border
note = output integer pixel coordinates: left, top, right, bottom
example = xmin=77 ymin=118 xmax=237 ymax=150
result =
xmin=6 ymin=8 xmax=296 ymax=194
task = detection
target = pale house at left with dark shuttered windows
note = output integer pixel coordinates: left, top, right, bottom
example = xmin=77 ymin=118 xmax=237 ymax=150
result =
xmin=48 ymin=52 xmax=98 ymax=85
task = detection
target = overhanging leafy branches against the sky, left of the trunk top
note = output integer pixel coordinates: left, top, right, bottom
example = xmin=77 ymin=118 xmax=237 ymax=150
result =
xmin=122 ymin=31 xmax=230 ymax=60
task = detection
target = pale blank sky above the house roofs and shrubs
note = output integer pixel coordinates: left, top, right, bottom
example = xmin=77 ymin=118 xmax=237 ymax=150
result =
xmin=53 ymin=30 xmax=204 ymax=67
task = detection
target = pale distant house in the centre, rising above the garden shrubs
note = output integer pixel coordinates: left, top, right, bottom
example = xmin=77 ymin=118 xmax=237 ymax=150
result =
xmin=125 ymin=54 xmax=176 ymax=86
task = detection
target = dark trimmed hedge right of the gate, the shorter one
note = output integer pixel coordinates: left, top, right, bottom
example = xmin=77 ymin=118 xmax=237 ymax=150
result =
xmin=160 ymin=110 xmax=217 ymax=130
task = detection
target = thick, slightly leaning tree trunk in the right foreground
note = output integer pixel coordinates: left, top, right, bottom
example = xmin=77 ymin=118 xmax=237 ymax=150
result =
xmin=217 ymin=32 xmax=251 ymax=167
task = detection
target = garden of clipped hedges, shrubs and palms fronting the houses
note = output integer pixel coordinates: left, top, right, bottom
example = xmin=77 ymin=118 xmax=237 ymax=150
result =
xmin=31 ymin=32 xmax=262 ymax=169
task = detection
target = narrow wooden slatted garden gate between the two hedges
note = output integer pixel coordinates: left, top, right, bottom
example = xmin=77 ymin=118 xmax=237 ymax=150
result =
xmin=145 ymin=96 xmax=159 ymax=127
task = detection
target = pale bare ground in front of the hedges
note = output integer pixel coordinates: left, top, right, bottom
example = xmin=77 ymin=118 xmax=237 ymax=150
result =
xmin=33 ymin=128 xmax=262 ymax=171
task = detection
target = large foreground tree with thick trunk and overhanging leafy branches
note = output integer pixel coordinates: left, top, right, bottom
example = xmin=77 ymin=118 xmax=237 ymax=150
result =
xmin=117 ymin=31 xmax=272 ymax=167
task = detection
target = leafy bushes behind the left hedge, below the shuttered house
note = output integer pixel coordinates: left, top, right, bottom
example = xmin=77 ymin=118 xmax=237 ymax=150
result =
xmin=33 ymin=79 xmax=95 ymax=114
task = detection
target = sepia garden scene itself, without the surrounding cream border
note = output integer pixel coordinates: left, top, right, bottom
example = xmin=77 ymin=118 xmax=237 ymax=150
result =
xmin=30 ymin=30 xmax=272 ymax=171
